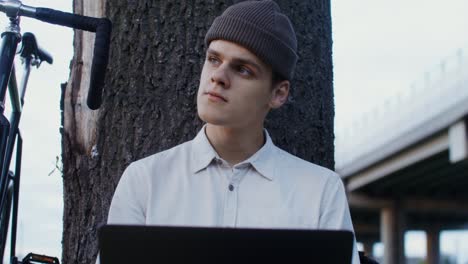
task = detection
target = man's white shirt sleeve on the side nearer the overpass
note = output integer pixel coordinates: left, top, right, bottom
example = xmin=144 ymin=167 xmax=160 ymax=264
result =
xmin=319 ymin=172 xmax=360 ymax=264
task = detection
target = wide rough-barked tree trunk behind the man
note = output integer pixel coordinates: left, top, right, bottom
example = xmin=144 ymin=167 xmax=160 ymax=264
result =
xmin=62 ymin=0 xmax=334 ymax=263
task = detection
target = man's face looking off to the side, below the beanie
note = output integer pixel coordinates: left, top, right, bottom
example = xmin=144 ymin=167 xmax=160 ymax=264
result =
xmin=197 ymin=40 xmax=289 ymax=128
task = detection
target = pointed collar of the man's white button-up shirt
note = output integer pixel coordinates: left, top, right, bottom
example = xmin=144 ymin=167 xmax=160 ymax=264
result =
xmin=192 ymin=125 xmax=276 ymax=180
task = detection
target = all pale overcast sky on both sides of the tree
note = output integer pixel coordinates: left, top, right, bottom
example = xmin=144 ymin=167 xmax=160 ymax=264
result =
xmin=2 ymin=0 xmax=468 ymax=258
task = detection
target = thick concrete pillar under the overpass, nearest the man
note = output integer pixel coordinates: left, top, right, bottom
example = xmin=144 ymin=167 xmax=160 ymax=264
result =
xmin=380 ymin=203 xmax=406 ymax=264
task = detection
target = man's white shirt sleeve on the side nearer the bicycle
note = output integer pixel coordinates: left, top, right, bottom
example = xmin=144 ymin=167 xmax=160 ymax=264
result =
xmin=107 ymin=163 xmax=149 ymax=225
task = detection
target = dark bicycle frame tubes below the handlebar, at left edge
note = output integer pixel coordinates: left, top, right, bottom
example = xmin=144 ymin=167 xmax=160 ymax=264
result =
xmin=0 ymin=20 xmax=51 ymax=263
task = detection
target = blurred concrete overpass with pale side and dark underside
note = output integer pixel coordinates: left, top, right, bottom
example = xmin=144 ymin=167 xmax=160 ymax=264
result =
xmin=336 ymin=50 xmax=468 ymax=264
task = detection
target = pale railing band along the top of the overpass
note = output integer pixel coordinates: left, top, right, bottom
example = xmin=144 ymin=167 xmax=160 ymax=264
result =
xmin=335 ymin=49 xmax=468 ymax=169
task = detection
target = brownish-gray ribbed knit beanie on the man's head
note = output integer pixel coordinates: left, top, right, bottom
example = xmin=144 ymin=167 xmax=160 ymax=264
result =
xmin=205 ymin=0 xmax=298 ymax=80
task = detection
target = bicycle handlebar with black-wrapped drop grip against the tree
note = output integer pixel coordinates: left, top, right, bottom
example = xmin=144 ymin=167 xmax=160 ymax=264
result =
xmin=0 ymin=1 xmax=112 ymax=110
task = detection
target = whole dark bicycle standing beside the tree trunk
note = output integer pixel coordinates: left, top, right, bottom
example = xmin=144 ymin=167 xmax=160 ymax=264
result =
xmin=0 ymin=0 xmax=111 ymax=264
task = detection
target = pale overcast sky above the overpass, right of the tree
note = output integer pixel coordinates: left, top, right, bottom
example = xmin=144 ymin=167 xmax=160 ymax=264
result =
xmin=332 ymin=0 xmax=468 ymax=119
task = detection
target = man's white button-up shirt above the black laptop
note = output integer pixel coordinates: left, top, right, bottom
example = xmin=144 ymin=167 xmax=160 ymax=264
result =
xmin=108 ymin=128 xmax=359 ymax=263
